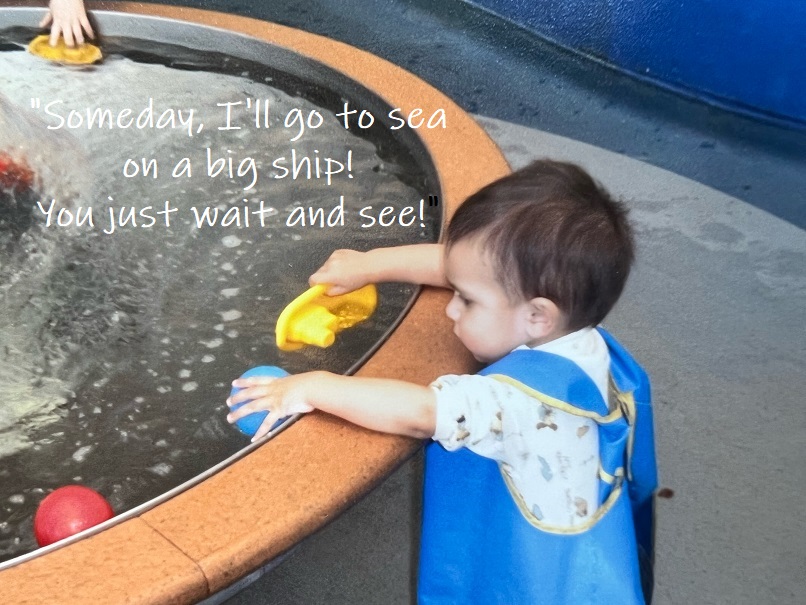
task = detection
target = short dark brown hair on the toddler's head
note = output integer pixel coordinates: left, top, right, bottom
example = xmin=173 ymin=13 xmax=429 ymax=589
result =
xmin=446 ymin=160 xmax=634 ymax=330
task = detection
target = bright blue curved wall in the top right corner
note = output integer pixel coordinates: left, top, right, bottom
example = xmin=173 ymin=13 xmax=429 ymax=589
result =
xmin=471 ymin=0 xmax=806 ymax=124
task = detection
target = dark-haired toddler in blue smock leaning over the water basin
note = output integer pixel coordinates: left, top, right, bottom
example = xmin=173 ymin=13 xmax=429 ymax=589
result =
xmin=228 ymin=160 xmax=656 ymax=605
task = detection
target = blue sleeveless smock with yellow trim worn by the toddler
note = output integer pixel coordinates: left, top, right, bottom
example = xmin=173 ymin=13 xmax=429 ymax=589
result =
xmin=418 ymin=328 xmax=657 ymax=605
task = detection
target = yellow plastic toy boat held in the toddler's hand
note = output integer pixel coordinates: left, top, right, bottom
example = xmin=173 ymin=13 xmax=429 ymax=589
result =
xmin=276 ymin=284 xmax=378 ymax=351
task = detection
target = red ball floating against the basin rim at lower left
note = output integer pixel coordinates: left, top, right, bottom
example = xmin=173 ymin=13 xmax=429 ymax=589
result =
xmin=34 ymin=485 xmax=115 ymax=546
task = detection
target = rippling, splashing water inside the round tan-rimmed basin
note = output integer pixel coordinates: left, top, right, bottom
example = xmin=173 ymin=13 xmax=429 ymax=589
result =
xmin=0 ymin=32 xmax=438 ymax=561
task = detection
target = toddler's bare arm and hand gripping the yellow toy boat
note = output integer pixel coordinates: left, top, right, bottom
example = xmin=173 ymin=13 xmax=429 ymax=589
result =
xmin=309 ymin=244 xmax=448 ymax=296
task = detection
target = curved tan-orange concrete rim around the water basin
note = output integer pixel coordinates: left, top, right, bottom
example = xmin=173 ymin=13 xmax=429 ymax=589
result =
xmin=0 ymin=0 xmax=509 ymax=604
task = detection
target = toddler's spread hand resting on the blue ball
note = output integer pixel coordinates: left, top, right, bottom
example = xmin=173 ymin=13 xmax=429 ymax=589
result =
xmin=227 ymin=374 xmax=314 ymax=441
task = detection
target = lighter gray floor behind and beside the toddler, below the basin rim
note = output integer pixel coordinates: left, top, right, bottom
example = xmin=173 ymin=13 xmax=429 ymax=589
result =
xmin=216 ymin=118 xmax=806 ymax=605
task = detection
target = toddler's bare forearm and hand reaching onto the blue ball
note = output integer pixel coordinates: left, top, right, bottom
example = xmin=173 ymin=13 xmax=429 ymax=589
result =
xmin=227 ymin=372 xmax=436 ymax=441
